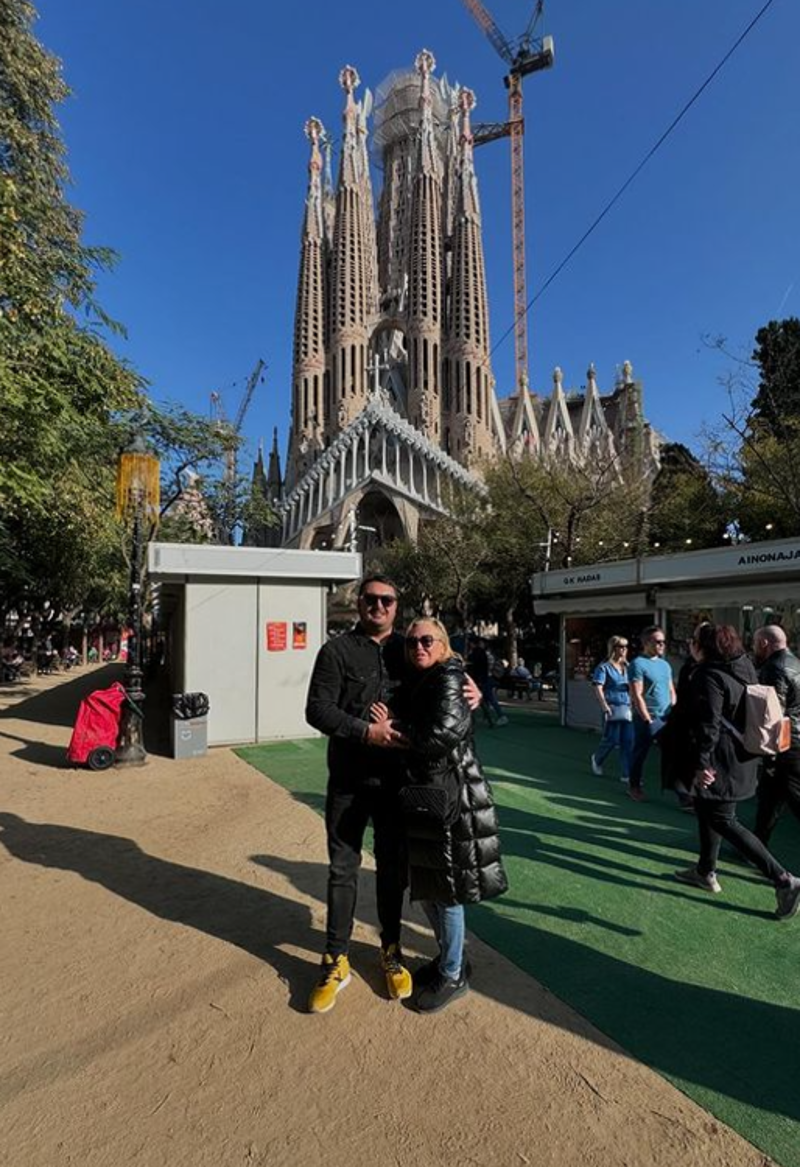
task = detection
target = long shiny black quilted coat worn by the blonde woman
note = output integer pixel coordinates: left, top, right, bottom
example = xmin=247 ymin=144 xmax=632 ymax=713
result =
xmin=403 ymin=658 xmax=508 ymax=904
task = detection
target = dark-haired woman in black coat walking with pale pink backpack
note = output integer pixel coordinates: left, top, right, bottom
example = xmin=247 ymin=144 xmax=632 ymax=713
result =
xmin=675 ymin=623 xmax=800 ymax=920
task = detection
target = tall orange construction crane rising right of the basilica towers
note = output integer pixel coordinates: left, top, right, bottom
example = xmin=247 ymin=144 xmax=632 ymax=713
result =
xmin=463 ymin=0 xmax=555 ymax=390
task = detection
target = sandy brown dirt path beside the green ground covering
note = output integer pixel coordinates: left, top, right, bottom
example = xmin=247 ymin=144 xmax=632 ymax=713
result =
xmin=0 ymin=671 xmax=769 ymax=1167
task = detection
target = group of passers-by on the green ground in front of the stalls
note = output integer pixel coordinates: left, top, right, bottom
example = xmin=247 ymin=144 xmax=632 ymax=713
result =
xmin=590 ymin=621 xmax=800 ymax=920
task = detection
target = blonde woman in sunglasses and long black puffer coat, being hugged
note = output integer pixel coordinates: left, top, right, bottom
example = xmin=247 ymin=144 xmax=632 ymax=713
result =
xmin=375 ymin=617 xmax=508 ymax=1013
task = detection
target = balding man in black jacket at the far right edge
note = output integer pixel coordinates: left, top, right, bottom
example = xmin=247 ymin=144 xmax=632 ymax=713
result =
xmin=753 ymin=624 xmax=800 ymax=844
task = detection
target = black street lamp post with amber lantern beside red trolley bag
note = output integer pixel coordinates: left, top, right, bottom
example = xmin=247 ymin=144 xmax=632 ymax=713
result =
xmin=117 ymin=434 xmax=159 ymax=766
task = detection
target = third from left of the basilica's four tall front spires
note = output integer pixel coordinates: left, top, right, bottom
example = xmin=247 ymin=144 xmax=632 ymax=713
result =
xmin=407 ymin=49 xmax=443 ymax=441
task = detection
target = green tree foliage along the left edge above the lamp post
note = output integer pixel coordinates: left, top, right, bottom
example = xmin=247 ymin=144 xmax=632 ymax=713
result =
xmin=0 ymin=0 xmax=282 ymax=634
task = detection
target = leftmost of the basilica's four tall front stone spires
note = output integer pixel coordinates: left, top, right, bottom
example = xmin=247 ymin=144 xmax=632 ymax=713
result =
xmin=290 ymin=118 xmax=325 ymax=478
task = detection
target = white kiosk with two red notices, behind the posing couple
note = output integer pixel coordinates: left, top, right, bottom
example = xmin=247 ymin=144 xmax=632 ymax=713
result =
xmin=148 ymin=543 xmax=362 ymax=746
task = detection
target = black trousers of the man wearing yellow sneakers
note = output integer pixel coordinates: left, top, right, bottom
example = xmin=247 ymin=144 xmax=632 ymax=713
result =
xmin=325 ymin=781 xmax=408 ymax=956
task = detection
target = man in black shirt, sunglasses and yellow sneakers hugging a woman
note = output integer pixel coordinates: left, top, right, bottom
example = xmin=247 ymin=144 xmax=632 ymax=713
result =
xmin=306 ymin=575 xmax=413 ymax=1013
